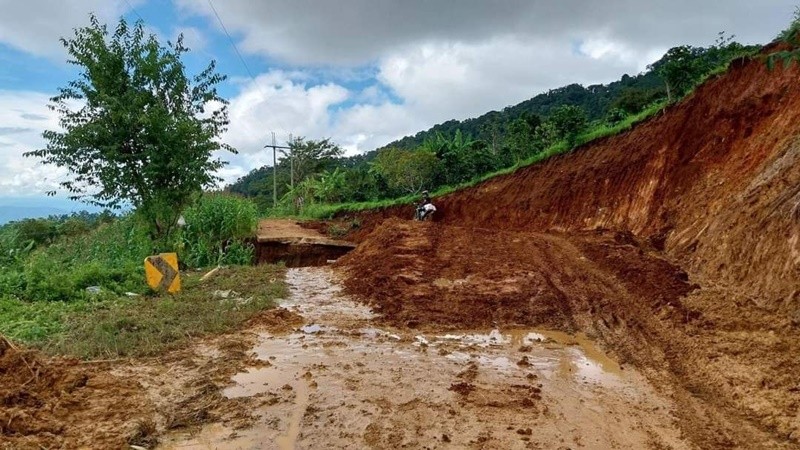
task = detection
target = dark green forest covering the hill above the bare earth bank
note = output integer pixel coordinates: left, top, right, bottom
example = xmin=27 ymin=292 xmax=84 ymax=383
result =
xmin=225 ymin=33 xmax=760 ymax=213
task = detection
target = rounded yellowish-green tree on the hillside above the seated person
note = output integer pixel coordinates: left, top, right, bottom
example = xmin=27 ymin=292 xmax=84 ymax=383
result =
xmin=371 ymin=148 xmax=439 ymax=194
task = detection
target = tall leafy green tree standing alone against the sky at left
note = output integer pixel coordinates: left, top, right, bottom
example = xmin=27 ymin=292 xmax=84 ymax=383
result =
xmin=25 ymin=15 xmax=235 ymax=244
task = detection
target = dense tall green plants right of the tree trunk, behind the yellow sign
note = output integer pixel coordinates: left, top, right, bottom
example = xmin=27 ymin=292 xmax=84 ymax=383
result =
xmin=181 ymin=194 xmax=258 ymax=267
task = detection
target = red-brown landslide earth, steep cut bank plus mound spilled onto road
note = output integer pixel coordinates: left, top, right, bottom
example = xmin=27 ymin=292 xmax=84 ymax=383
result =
xmin=342 ymin=47 xmax=800 ymax=448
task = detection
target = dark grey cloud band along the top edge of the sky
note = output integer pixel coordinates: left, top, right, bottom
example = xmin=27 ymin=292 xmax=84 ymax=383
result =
xmin=175 ymin=0 xmax=796 ymax=65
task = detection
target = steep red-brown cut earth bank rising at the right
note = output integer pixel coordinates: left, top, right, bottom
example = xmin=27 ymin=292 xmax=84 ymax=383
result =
xmin=342 ymin=51 xmax=800 ymax=310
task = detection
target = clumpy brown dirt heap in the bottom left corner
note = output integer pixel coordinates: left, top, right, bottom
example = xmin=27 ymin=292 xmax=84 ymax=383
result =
xmin=0 ymin=336 xmax=154 ymax=449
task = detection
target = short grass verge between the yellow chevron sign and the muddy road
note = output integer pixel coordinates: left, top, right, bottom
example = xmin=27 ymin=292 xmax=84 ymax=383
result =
xmin=0 ymin=265 xmax=286 ymax=358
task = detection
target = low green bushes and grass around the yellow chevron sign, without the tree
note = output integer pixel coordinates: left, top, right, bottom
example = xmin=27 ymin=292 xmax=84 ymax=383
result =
xmin=0 ymin=194 xmax=276 ymax=358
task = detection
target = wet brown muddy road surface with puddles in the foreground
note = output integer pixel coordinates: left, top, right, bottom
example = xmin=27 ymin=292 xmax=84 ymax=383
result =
xmin=162 ymin=268 xmax=691 ymax=449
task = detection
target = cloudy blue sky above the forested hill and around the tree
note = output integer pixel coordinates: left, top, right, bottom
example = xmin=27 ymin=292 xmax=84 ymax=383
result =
xmin=0 ymin=0 xmax=797 ymax=209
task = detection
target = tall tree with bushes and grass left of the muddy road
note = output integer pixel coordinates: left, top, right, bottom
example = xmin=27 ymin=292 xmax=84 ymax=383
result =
xmin=0 ymin=16 xmax=285 ymax=358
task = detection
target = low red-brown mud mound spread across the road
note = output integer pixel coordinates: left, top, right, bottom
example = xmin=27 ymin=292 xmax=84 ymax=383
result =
xmin=340 ymin=219 xmax=692 ymax=331
